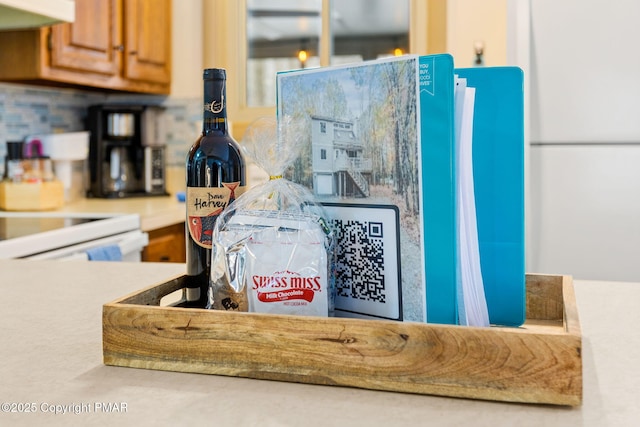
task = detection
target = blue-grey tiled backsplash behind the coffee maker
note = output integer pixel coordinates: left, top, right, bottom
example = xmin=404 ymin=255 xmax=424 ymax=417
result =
xmin=0 ymin=83 xmax=202 ymax=176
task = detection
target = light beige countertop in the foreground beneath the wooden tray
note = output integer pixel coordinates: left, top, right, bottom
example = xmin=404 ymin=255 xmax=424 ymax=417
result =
xmin=0 ymin=260 xmax=640 ymax=427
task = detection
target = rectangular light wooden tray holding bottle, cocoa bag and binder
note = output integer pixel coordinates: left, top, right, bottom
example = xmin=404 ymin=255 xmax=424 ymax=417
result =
xmin=102 ymin=275 xmax=582 ymax=406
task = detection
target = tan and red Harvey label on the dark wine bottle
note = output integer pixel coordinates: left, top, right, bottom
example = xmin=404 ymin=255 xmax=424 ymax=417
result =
xmin=186 ymin=182 xmax=246 ymax=249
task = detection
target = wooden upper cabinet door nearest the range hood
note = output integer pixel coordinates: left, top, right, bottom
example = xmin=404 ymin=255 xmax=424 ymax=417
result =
xmin=50 ymin=0 xmax=123 ymax=75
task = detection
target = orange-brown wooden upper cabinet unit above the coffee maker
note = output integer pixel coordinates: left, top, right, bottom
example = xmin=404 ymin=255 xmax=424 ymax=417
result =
xmin=0 ymin=0 xmax=171 ymax=94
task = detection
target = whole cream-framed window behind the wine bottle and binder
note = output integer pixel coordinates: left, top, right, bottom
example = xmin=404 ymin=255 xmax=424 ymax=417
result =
xmin=202 ymin=0 xmax=432 ymax=130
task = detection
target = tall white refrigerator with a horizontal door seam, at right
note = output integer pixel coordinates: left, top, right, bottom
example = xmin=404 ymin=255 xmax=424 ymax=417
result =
xmin=518 ymin=0 xmax=640 ymax=281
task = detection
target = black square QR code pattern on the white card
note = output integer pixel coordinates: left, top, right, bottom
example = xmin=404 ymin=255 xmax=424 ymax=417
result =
xmin=332 ymin=219 xmax=386 ymax=303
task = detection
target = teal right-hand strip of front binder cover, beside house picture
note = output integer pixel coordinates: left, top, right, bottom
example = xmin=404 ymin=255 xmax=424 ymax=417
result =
xmin=419 ymin=54 xmax=458 ymax=324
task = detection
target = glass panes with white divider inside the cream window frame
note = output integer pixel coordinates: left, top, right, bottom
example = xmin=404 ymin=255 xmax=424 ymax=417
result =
xmin=244 ymin=0 xmax=410 ymax=108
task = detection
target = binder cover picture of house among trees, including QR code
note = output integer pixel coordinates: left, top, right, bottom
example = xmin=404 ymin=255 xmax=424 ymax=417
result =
xmin=277 ymin=56 xmax=426 ymax=321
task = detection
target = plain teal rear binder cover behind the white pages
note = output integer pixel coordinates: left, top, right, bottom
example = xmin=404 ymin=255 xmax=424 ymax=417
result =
xmin=455 ymin=67 xmax=526 ymax=326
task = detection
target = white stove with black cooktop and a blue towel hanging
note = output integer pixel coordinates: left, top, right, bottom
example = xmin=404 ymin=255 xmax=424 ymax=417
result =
xmin=0 ymin=212 xmax=149 ymax=262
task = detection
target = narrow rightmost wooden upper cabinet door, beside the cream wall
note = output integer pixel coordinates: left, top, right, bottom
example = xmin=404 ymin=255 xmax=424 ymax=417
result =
xmin=124 ymin=0 xmax=171 ymax=84
